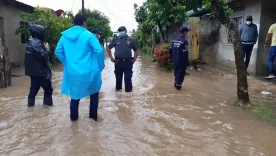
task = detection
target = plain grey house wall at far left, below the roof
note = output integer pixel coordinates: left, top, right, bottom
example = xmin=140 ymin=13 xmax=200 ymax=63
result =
xmin=0 ymin=1 xmax=28 ymax=64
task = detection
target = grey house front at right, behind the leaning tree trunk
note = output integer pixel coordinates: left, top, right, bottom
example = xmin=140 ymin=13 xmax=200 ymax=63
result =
xmin=200 ymin=0 xmax=276 ymax=75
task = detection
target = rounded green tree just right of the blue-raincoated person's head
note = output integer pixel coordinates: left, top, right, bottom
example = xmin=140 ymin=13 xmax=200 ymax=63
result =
xmin=79 ymin=9 xmax=113 ymax=40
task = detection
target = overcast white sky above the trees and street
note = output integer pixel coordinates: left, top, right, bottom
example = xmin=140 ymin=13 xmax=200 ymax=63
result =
xmin=18 ymin=0 xmax=146 ymax=31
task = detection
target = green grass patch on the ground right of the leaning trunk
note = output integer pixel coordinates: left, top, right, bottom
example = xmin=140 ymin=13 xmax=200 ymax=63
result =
xmin=252 ymin=102 xmax=276 ymax=123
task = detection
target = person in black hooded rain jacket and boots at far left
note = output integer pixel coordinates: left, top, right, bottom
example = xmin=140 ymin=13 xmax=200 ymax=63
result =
xmin=25 ymin=25 xmax=53 ymax=107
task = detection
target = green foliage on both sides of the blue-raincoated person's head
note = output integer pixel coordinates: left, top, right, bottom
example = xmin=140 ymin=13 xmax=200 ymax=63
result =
xmin=16 ymin=7 xmax=113 ymax=65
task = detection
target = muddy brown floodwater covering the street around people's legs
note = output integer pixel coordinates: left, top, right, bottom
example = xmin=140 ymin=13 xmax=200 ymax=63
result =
xmin=0 ymin=56 xmax=276 ymax=156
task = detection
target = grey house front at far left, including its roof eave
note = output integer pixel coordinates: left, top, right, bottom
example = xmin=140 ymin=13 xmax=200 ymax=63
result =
xmin=0 ymin=0 xmax=34 ymax=65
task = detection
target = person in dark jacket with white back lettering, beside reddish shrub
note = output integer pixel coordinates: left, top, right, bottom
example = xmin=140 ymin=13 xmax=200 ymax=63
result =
xmin=169 ymin=25 xmax=190 ymax=90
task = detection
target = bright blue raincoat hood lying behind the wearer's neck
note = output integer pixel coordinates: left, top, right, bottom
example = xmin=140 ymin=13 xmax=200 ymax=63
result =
xmin=61 ymin=26 xmax=86 ymax=42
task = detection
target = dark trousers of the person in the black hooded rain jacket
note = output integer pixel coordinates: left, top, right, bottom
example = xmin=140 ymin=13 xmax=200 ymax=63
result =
xmin=28 ymin=77 xmax=53 ymax=99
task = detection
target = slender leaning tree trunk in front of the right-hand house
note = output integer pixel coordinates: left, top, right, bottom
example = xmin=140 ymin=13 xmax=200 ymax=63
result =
xmin=211 ymin=0 xmax=250 ymax=106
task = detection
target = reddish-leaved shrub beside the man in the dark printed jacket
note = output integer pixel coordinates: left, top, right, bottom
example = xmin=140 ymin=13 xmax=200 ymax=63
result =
xmin=154 ymin=43 xmax=173 ymax=70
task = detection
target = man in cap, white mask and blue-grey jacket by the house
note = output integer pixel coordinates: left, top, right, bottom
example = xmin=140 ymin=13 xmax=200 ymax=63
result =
xmin=239 ymin=16 xmax=259 ymax=75
